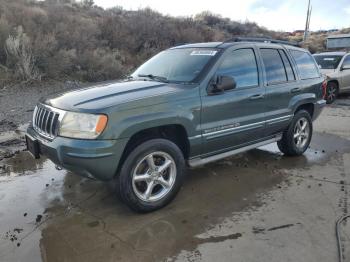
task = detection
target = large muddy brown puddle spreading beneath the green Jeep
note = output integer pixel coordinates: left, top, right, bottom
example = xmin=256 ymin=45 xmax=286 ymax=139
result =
xmin=0 ymin=135 xmax=350 ymax=261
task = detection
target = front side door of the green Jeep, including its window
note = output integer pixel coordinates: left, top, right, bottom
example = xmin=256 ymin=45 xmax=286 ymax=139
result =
xmin=201 ymin=47 xmax=265 ymax=156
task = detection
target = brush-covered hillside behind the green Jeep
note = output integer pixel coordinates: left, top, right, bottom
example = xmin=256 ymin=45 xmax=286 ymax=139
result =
xmin=0 ymin=0 xmax=348 ymax=86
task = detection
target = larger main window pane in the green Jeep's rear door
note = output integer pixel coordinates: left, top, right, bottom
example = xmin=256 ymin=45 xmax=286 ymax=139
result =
xmin=260 ymin=48 xmax=287 ymax=85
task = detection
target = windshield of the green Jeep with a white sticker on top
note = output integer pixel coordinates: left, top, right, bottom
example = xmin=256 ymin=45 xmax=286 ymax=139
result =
xmin=132 ymin=48 xmax=218 ymax=82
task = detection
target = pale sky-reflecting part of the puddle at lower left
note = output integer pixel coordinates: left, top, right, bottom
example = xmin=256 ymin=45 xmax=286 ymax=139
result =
xmin=0 ymin=155 xmax=65 ymax=261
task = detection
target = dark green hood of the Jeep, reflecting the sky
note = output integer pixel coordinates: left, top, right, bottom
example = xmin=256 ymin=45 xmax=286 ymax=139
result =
xmin=40 ymin=80 xmax=183 ymax=111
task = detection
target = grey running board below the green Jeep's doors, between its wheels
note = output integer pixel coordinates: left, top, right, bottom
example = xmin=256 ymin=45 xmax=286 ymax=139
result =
xmin=188 ymin=134 xmax=282 ymax=167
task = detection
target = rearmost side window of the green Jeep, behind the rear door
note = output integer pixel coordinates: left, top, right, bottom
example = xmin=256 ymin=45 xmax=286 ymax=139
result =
xmin=290 ymin=50 xmax=320 ymax=79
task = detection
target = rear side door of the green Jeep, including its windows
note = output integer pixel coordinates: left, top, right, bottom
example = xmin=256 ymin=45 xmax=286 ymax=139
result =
xmin=260 ymin=47 xmax=301 ymax=136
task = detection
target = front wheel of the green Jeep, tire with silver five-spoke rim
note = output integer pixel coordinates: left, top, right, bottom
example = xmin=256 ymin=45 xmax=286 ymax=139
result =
xmin=116 ymin=139 xmax=186 ymax=213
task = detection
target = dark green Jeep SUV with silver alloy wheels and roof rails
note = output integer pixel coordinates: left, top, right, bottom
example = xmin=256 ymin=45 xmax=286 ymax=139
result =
xmin=26 ymin=39 xmax=326 ymax=212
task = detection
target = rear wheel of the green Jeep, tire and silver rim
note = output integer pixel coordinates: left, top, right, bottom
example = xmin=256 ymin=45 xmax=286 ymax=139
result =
xmin=277 ymin=110 xmax=313 ymax=156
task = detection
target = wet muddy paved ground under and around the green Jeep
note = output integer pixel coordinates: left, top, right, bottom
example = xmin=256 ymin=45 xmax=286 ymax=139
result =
xmin=0 ymin=97 xmax=350 ymax=262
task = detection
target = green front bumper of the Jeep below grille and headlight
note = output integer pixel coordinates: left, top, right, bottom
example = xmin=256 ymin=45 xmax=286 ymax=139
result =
xmin=27 ymin=126 xmax=128 ymax=181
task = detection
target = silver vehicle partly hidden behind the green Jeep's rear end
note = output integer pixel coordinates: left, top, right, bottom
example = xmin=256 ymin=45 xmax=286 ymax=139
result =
xmin=314 ymin=52 xmax=350 ymax=104
